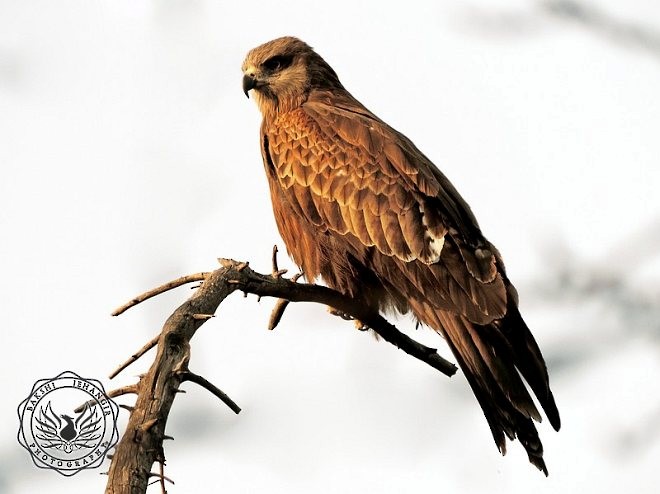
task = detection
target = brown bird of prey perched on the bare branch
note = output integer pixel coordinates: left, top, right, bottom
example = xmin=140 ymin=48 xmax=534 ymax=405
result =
xmin=242 ymin=37 xmax=560 ymax=475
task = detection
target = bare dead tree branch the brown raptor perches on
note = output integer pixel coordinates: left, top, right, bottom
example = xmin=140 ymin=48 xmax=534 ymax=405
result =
xmin=106 ymin=253 xmax=456 ymax=494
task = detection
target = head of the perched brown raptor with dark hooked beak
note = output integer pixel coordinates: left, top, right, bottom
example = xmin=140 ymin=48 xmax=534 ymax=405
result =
xmin=242 ymin=36 xmax=341 ymax=116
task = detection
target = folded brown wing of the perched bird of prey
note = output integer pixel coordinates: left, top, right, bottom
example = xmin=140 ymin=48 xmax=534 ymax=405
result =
xmin=268 ymin=94 xmax=506 ymax=324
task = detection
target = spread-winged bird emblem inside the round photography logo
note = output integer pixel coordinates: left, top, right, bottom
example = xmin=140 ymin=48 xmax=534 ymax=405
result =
xmin=35 ymin=401 xmax=102 ymax=454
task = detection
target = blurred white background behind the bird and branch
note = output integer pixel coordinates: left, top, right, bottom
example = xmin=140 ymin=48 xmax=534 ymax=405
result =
xmin=0 ymin=0 xmax=660 ymax=494
